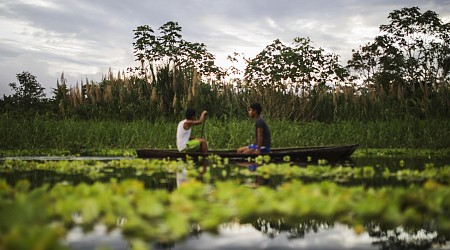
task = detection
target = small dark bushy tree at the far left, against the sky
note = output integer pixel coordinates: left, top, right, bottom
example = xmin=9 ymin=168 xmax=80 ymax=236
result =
xmin=9 ymin=71 xmax=45 ymax=108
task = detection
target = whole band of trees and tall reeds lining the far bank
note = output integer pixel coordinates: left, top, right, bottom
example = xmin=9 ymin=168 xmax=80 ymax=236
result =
xmin=0 ymin=7 xmax=450 ymax=122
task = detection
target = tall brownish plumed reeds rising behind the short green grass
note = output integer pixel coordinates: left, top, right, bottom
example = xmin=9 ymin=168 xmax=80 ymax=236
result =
xmin=47 ymin=67 xmax=450 ymax=122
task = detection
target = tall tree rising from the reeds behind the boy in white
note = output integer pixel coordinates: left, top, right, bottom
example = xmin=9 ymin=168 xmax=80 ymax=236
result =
xmin=133 ymin=22 xmax=224 ymax=114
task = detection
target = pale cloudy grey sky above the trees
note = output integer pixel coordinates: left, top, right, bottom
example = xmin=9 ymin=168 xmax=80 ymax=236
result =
xmin=0 ymin=0 xmax=450 ymax=98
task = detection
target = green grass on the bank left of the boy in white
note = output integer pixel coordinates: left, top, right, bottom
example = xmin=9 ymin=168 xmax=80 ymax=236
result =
xmin=0 ymin=115 xmax=174 ymax=152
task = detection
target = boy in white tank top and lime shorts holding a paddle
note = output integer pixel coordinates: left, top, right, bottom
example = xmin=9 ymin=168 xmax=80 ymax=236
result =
xmin=177 ymin=108 xmax=208 ymax=153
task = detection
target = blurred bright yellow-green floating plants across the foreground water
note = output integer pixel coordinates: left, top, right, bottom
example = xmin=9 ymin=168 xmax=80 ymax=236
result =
xmin=0 ymin=171 xmax=450 ymax=249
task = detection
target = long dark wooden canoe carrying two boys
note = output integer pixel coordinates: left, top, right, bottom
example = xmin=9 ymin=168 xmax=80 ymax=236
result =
xmin=136 ymin=144 xmax=358 ymax=161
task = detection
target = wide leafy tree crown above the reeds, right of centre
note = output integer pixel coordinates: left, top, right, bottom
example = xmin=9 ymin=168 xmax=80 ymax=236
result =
xmin=244 ymin=38 xmax=348 ymax=94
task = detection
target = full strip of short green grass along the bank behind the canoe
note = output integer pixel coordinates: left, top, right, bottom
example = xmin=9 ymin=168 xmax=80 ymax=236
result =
xmin=0 ymin=115 xmax=450 ymax=153
